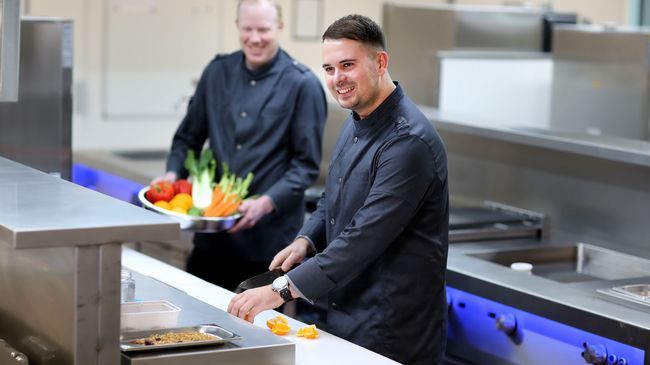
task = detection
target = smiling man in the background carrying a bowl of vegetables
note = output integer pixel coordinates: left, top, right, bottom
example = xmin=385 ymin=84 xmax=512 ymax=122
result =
xmin=159 ymin=0 xmax=327 ymax=290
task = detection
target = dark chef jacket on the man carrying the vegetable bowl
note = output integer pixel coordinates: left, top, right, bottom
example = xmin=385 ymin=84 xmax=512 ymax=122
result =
xmin=167 ymin=49 xmax=327 ymax=262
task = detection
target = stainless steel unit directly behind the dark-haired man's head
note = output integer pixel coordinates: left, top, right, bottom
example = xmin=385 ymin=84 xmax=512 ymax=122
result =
xmin=383 ymin=3 xmax=546 ymax=106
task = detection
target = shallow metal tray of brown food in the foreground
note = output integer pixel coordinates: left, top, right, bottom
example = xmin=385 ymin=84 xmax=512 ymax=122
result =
xmin=120 ymin=324 xmax=241 ymax=352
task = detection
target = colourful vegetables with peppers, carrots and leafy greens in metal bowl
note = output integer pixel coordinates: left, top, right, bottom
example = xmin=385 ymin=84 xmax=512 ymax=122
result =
xmin=145 ymin=149 xmax=253 ymax=217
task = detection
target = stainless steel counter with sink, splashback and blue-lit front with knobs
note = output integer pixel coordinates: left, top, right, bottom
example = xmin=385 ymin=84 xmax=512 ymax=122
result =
xmin=423 ymin=96 xmax=650 ymax=365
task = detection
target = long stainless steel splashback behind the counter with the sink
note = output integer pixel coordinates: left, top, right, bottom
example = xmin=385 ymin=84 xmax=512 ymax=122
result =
xmin=439 ymin=129 xmax=650 ymax=251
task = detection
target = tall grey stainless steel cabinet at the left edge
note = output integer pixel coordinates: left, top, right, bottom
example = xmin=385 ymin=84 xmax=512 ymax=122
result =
xmin=0 ymin=18 xmax=72 ymax=180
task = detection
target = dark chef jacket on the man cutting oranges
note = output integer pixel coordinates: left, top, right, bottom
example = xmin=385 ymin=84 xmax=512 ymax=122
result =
xmin=288 ymin=85 xmax=449 ymax=365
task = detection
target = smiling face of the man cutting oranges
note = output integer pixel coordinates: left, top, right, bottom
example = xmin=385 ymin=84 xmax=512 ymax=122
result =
xmin=323 ymin=38 xmax=382 ymax=118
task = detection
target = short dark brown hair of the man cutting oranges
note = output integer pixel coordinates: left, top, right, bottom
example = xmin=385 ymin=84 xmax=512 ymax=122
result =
xmin=323 ymin=14 xmax=386 ymax=51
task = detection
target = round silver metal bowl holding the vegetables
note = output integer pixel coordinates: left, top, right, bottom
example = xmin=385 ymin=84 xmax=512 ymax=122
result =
xmin=138 ymin=186 xmax=242 ymax=233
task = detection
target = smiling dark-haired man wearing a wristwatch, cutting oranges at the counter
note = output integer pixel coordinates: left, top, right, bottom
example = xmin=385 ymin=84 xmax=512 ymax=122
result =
xmin=228 ymin=15 xmax=449 ymax=364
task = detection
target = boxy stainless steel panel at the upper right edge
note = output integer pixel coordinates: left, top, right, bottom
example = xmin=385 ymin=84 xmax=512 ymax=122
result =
xmin=550 ymin=25 xmax=650 ymax=140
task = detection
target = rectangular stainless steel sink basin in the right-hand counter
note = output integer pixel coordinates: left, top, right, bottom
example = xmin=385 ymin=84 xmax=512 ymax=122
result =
xmin=467 ymin=243 xmax=650 ymax=283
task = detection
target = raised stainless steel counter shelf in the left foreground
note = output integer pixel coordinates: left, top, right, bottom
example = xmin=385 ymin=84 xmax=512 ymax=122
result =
xmin=0 ymin=157 xmax=179 ymax=365
